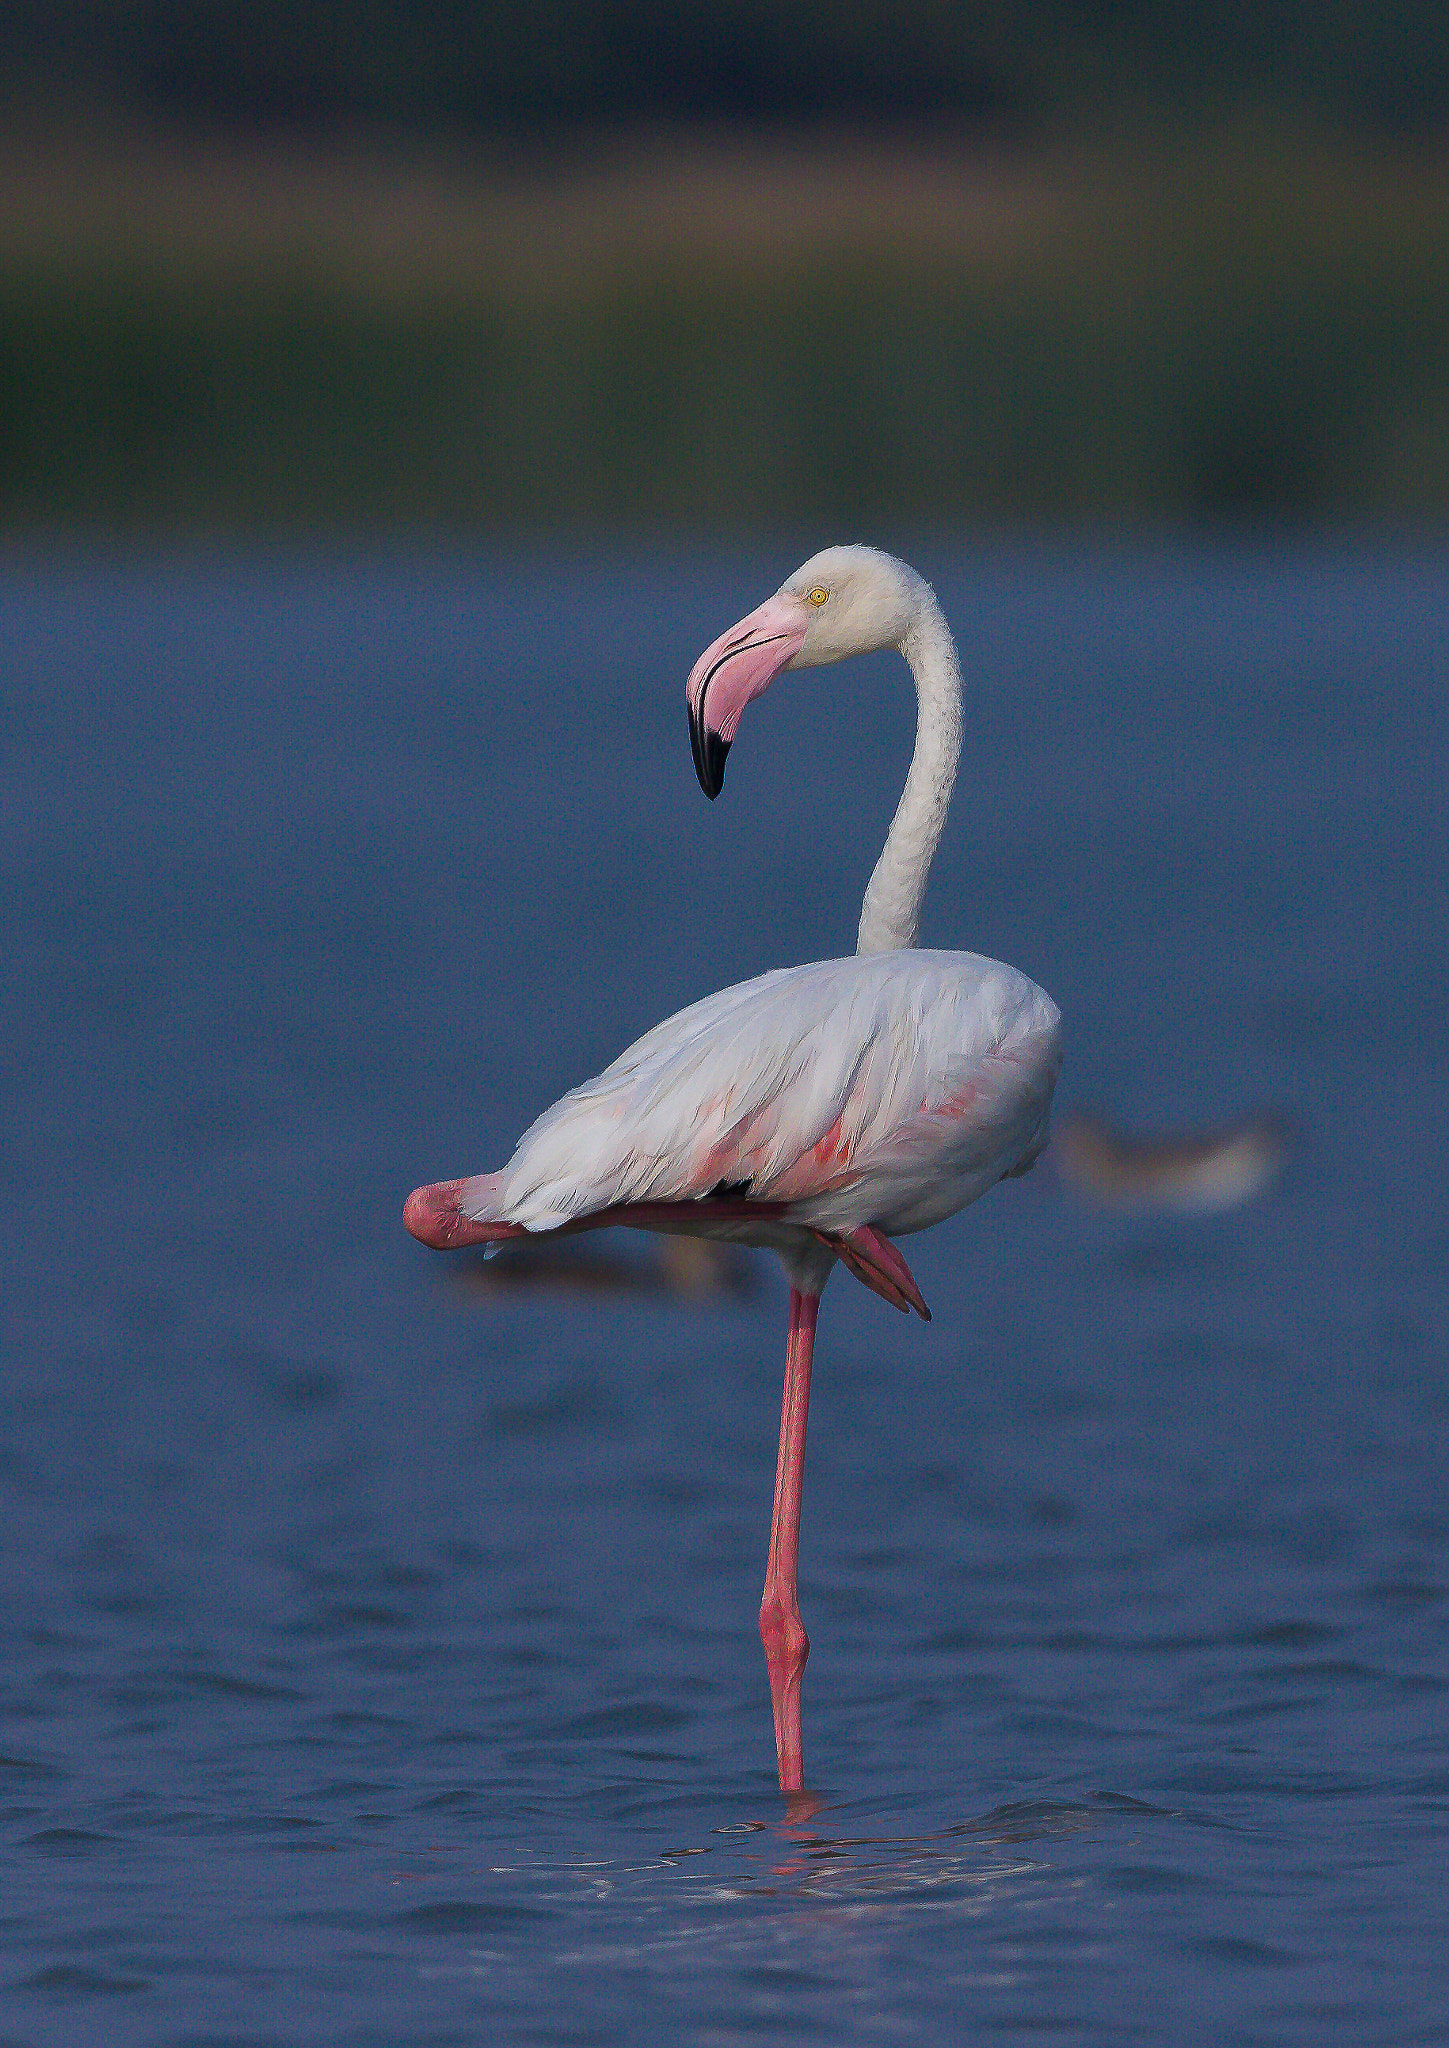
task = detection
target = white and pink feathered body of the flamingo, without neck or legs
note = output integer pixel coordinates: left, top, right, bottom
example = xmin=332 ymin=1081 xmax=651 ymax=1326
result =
xmin=480 ymin=952 xmax=1060 ymax=1243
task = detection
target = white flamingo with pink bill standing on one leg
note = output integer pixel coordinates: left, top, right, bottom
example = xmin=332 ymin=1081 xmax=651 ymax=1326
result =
xmin=403 ymin=547 xmax=1060 ymax=1792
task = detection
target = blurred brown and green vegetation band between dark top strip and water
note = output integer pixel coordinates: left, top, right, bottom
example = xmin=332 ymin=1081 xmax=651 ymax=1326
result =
xmin=0 ymin=137 xmax=1449 ymax=535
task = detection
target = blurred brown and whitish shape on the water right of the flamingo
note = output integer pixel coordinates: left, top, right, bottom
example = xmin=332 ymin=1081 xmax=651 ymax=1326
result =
xmin=1050 ymin=1110 xmax=1298 ymax=1217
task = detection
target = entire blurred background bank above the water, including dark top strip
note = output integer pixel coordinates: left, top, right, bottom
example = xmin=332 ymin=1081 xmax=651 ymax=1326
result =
xmin=0 ymin=0 xmax=1449 ymax=535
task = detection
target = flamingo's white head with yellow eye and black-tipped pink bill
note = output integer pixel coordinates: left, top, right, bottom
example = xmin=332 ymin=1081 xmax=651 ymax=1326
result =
xmin=684 ymin=547 xmax=925 ymax=797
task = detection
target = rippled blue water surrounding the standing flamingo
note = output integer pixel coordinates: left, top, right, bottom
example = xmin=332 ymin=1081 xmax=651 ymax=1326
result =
xmin=0 ymin=537 xmax=1449 ymax=2048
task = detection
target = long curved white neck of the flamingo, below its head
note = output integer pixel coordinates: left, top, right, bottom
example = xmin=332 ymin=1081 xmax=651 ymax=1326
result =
xmin=855 ymin=584 xmax=962 ymax=952
